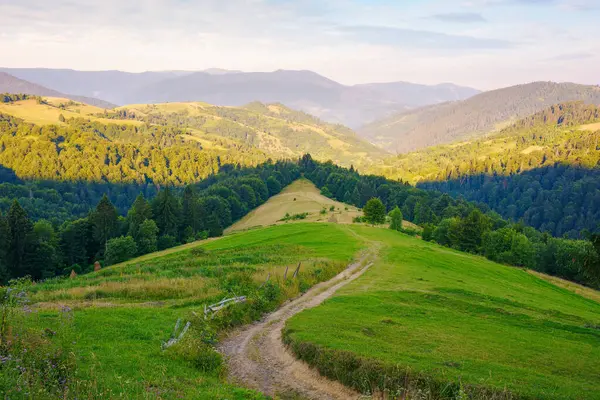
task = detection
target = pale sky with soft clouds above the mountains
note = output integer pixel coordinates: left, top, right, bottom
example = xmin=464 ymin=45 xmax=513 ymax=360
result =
xmin=0 ymin=0 xmax=600 ymax=90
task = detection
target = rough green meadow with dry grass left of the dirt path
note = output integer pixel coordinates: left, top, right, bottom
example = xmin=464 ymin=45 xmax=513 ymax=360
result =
xmin=9 ymin=224 xmax=363 ymax=399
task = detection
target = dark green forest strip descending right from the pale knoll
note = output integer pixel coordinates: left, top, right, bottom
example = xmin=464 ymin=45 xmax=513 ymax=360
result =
xmin=308 ymin=156 xmax=600 ymax=288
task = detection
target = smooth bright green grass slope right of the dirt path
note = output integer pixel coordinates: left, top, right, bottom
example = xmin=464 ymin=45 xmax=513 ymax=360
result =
xmin=284 ymin=226 xmax=600 ymax=399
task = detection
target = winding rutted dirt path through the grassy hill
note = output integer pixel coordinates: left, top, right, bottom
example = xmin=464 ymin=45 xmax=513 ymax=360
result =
xmin=219 ymin=251 xmax=375 ymax=400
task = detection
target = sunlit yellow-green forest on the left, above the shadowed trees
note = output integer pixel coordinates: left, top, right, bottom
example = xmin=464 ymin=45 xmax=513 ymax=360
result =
xmin=0 ymin=114 xmax=267 ymax=185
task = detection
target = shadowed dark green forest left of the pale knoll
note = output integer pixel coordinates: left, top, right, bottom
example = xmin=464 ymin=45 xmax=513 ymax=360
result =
xmin=0 ymin=161 xmax=300 ymax=282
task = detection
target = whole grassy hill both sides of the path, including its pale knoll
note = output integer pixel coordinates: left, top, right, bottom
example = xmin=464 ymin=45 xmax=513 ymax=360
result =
xmin=0 ymin=180 xmax=600 ymax=400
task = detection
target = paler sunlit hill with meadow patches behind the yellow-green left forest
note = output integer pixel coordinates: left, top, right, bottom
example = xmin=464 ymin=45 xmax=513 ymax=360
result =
xmin=113 ymin=102 xmax=387 ymax=166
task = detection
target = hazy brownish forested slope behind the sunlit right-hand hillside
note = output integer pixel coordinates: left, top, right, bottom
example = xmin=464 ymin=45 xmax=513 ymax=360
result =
xmin=359 ymin=82 xmax=600 ymax=153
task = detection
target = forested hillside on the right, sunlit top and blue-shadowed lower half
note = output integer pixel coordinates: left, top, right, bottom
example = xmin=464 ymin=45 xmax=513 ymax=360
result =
xmin=369 ymin=103 xmax=600 ymax=238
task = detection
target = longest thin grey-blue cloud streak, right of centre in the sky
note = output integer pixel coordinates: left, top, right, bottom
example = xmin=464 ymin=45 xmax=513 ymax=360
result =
xmin=336 ymin=26 xmax=514 ymax=50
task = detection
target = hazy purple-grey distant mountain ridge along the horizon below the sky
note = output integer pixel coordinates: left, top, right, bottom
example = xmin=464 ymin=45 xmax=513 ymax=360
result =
xmin=0 ymin=68 xmax=480 ymax=128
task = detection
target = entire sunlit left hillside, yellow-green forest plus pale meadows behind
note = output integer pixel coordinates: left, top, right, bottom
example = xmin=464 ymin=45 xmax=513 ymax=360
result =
xmin=0 ymin=95 xmax=386 ymax=184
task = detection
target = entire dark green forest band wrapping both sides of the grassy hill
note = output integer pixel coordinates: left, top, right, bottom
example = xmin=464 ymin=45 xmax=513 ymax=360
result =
xmin=0 ymin=155 xmax=600 ymax=287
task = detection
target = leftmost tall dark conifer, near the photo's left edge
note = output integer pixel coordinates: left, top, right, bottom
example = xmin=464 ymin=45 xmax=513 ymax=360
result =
xmin=8 ymin=200 xmax=33 ymax=277
